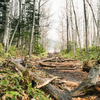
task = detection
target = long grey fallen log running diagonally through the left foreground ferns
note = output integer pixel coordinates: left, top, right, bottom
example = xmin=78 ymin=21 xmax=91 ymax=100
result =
xmin=7 ymin=59 xmax=72 ymax=100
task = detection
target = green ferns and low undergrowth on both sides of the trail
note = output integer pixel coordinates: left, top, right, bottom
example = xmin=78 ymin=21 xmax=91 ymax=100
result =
xmin=0 ymin=44 xmax=100 ymax=100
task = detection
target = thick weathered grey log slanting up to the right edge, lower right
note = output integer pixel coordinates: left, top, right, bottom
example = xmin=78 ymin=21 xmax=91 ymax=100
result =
xmin=71 ymin=64 xmax=100 ymax=96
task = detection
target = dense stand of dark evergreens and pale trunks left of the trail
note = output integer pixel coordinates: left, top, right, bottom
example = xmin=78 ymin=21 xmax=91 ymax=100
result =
xmin=0 ymin=0 xmax=49 ymax=55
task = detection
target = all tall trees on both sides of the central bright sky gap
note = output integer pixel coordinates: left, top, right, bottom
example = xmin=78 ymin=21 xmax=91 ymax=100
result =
xmin=0 ymin=0 xmax=100 ymax=55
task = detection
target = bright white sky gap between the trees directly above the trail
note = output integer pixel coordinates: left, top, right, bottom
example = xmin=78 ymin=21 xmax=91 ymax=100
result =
xmin=48 ymin=0 xmax=65 ymax=40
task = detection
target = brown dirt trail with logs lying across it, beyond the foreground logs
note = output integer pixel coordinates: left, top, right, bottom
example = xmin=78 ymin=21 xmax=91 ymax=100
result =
xmin=40 ymin=54 xmax=87 ymax=83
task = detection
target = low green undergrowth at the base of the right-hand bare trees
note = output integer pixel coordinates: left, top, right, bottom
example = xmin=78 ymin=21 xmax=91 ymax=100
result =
xmin=60 ymin=46 xmax=100 ymax=61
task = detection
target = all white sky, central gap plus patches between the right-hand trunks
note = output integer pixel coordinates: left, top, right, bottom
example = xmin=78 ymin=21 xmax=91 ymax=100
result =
xmin=48 ymin=0 xmax=97 ymax=40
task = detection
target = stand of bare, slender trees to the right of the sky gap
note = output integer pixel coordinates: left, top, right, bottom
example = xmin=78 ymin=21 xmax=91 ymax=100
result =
xmin=62 ymin=0 xmax=100 ymax=54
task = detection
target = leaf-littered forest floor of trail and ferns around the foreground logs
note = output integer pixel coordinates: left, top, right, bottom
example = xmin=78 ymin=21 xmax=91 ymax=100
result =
xmin=0 ymin=54 xmax=99 ymax=100
